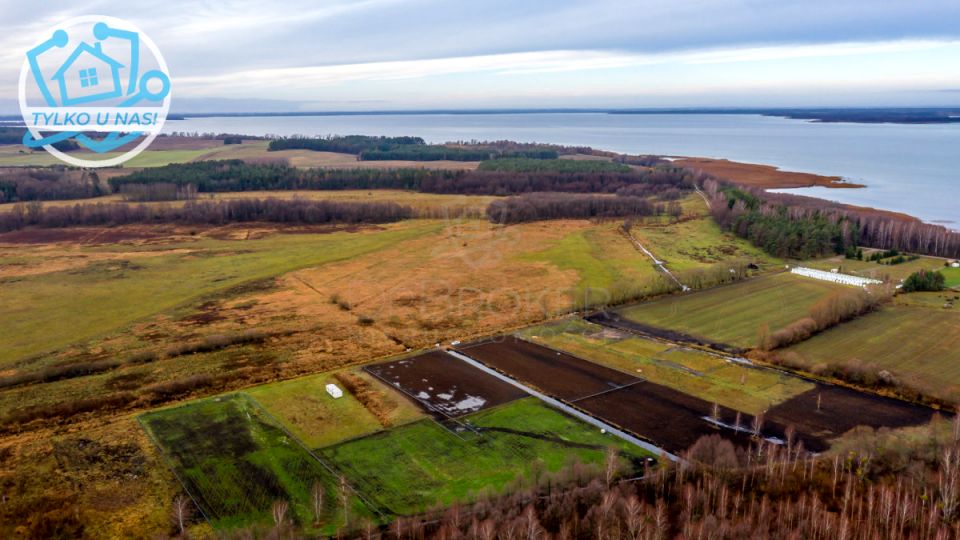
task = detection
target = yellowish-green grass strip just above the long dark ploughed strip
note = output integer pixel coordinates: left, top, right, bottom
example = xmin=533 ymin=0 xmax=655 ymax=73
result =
xmin=519 ymin=319 xmax=813 ymax=414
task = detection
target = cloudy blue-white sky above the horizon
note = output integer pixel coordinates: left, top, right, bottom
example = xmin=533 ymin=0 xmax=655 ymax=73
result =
xmin=0 ymin=0 xmax=960 ymax=114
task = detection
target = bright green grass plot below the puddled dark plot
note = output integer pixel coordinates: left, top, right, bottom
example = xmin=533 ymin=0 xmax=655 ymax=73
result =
xmin=321 ymin=398 xmax=646 ymax=514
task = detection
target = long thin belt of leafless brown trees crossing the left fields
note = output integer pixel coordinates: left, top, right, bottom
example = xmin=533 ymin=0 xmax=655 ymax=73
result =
xmin=0 ymin=199 xmax=414 ymax=232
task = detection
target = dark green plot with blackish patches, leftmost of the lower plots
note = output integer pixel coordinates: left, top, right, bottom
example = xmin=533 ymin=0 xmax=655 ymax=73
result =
xmin=141 ymin=394 xmax=372 ymax=534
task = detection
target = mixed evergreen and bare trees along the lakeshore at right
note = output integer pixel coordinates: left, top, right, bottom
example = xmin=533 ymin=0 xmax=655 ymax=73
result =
xmin=702 ymin=178 xmax=960 ymax=259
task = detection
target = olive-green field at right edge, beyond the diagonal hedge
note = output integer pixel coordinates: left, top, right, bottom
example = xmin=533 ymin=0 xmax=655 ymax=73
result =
xmin=784 ymin=302 xmax=960 ymax=400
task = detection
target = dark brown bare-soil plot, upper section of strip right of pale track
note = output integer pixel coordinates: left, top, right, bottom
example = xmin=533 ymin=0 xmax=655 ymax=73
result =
xmin=459 ymin=336 xmax=639 ymax=401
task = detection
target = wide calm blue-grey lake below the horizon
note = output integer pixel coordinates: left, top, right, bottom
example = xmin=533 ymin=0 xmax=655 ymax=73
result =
xmin=165 ymin=113 xmax=960 ymax=228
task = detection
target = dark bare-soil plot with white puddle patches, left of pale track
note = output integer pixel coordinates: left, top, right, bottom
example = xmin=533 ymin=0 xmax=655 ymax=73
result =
xmin=364 ymin=351 xmax=526 ymax=417
